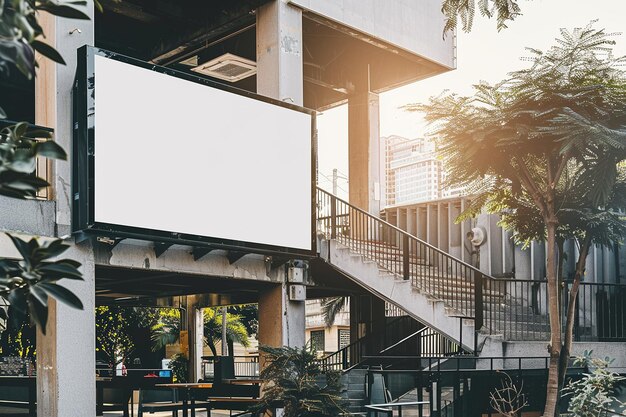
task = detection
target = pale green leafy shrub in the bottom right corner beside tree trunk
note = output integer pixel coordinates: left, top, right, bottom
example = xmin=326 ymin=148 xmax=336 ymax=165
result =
xmin=563 ymin=351 xmax=626 ymax=417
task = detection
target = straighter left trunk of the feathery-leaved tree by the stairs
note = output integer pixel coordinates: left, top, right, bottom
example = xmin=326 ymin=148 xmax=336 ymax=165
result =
xmin=543 ymin=219 xmax=561 ymax=417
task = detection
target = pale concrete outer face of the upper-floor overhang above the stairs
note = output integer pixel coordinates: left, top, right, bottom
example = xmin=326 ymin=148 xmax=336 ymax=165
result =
xmin=290 ymin=0 xmax=456 ymax=68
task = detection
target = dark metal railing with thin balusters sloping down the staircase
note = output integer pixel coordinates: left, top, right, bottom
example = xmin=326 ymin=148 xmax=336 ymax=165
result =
xmin=317 ymin=187 xmax=496 ymax=347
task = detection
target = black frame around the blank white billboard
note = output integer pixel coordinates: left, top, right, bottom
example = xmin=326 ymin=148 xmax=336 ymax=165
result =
xmin=71 ymin=45 xmax=317 ymax=259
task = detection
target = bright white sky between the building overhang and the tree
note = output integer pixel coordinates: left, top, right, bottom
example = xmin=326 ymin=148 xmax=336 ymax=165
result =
xmin=318 ymin=0 xmax=626 ymax=194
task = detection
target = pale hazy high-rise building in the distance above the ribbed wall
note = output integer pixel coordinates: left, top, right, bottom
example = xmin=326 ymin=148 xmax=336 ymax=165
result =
xmin=381 ymin=135 xmax=462 ymax=206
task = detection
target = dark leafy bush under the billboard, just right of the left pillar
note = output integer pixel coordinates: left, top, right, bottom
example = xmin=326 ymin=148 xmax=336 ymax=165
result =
xmin=96 ymin=306 xmax=135 ymax=367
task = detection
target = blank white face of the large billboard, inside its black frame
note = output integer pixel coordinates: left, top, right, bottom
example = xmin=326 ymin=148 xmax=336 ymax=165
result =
xmin=76 ymin=54 xmax=313 ymax=251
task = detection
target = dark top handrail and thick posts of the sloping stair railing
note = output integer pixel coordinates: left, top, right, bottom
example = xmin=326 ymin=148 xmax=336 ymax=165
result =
xmin=316 ymin=186 xmax=495 ymax=347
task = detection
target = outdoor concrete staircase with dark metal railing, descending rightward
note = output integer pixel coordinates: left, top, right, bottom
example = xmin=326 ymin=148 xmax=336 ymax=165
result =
xmin=317 ymin=188 xmax=549 ymax=354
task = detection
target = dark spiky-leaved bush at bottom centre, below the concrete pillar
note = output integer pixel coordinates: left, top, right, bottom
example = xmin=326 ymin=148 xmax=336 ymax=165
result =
xmin=253 ymin=346 xmax=346 ymax=417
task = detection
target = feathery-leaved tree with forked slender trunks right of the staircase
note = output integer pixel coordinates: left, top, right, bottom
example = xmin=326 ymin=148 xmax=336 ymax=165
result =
xmin=408 ymin=22 xmax=626 ymax=417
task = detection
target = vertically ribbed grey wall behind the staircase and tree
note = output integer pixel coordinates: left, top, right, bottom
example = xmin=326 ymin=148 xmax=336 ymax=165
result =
xmin=383 ymin=197 xmax=626 ymax=283
